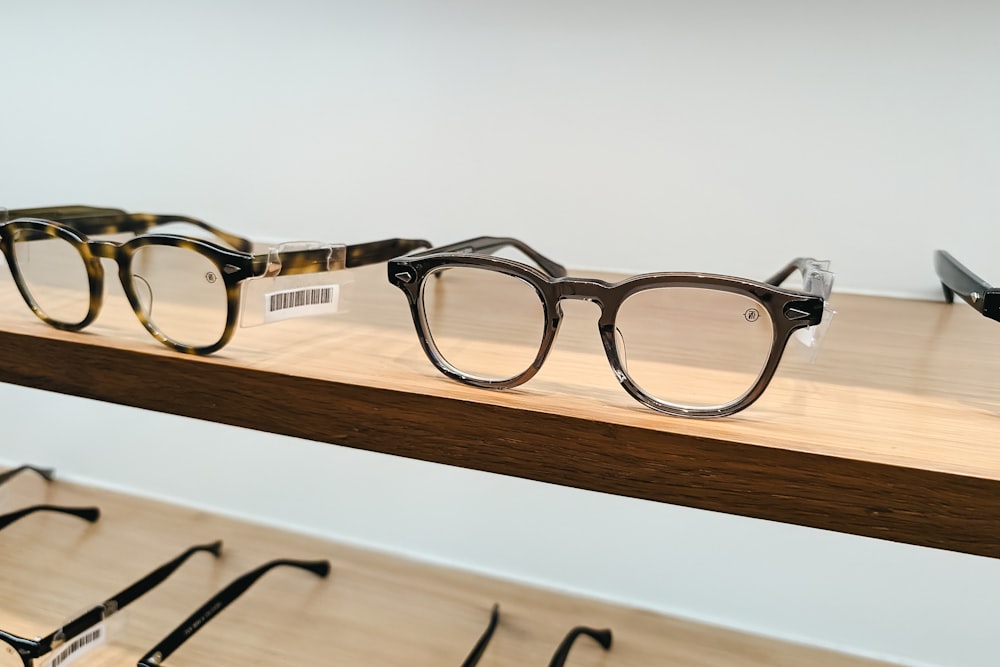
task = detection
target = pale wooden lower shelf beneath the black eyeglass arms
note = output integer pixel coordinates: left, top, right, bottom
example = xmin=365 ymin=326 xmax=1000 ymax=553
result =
xmin=0 ymin=475 xmax=886 ymax=667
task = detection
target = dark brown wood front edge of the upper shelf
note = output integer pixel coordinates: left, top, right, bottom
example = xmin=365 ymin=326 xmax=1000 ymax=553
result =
xmin=0 ymin=331 xmax=1000 ymax=558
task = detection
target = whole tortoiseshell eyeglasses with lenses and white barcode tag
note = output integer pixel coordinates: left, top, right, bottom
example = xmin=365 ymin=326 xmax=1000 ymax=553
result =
xmin=0 ymin=206 xmax=430 ymax=354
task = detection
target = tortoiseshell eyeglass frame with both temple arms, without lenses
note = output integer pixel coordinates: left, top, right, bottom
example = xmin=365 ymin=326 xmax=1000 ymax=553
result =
xmin=0 ymin=206 xmax=430 ymax=355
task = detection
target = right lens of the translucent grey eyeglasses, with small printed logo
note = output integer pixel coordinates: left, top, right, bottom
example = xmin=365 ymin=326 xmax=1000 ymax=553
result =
xmin=615 ymin=287 xmax=774 ymax=408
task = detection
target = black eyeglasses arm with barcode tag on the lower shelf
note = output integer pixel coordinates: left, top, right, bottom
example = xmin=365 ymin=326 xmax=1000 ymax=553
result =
xmin=0 ymin=542 xmax=222 ymax=667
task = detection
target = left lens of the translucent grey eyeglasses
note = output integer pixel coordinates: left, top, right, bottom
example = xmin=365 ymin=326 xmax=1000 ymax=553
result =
xmin=422 ymin=267 xmax=545 ymax=380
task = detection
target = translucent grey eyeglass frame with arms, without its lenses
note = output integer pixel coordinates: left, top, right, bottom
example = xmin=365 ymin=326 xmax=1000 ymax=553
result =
xmin=387 ymin=236 xmax=825 ymax=418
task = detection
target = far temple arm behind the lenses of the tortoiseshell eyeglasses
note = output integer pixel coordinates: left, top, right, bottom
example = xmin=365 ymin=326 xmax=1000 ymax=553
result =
xmin=7 ymin=205 xmax=253 ymax=252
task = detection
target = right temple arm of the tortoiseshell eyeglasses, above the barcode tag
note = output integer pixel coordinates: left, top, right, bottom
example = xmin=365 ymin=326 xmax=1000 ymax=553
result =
xmin=253 ymin=239 xmax=431 ymax=276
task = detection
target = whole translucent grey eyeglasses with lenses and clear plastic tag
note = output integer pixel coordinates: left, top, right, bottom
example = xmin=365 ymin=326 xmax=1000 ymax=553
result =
xmin=388 ymin=237 xmax=833 ymax=417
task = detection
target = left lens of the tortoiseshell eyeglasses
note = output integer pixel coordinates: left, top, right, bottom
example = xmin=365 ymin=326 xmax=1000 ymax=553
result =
xmin=12 ymin=229 xmax=90 ymax=325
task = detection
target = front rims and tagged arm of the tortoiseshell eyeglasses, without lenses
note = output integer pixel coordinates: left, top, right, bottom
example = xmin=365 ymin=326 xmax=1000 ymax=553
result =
xmin=0 ymin=218 xmax=430 ymax=355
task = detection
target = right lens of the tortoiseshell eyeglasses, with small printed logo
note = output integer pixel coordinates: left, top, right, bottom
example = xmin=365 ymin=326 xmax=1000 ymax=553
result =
xmin=130 ymin=245 xmax=227 ymax=347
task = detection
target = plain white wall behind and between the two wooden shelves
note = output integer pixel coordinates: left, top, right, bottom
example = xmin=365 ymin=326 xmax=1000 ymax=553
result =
xmin=0 ymin=0 xmax=1000 ymax=665
